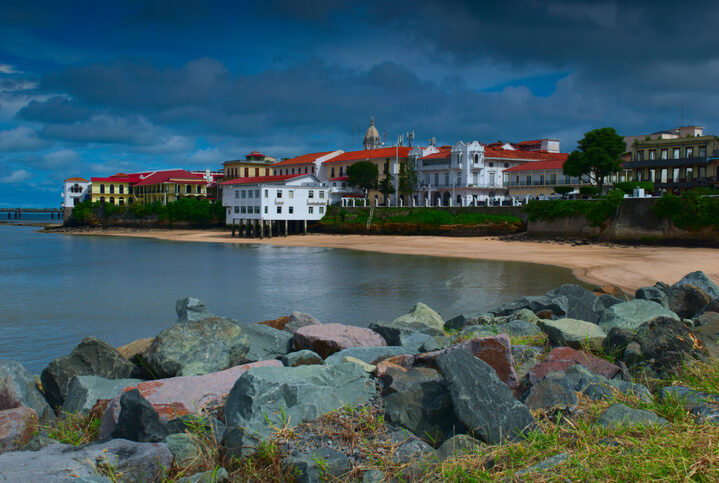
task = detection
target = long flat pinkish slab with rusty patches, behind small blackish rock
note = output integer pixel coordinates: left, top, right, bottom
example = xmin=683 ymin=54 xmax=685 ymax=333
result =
xmin=96 ymin=359 xmax=282 ymax=438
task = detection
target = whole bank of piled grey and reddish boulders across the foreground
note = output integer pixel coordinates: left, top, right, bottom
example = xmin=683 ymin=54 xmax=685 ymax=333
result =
xmin=0 ymin=272 xmax=719 ymax=482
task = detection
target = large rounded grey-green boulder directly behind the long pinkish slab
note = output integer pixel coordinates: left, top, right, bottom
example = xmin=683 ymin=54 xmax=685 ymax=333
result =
xmin=146 ymin=317 xmax=292 ymax=378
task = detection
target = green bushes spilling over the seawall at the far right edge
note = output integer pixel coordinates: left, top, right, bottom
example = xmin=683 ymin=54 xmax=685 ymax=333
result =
xmin=652 ymin=188 xmax=719 ymax=230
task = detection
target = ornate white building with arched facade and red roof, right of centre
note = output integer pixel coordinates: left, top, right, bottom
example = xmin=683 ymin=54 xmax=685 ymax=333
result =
xmin=410 ymin=139 xmax=568 ymax=206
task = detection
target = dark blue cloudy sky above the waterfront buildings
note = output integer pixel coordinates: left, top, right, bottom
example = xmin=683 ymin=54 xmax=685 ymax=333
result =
xmin=0 ymin=0 xmax=719 ymax=207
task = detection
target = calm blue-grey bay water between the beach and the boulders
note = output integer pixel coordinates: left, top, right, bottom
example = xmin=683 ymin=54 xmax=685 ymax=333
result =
xmin=0 ymin=224 xmax=576 ymax=373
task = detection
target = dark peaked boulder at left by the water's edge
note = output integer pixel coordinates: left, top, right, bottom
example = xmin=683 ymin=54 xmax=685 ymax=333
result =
xmin=40 ymin=337 xmax=134 ymax=408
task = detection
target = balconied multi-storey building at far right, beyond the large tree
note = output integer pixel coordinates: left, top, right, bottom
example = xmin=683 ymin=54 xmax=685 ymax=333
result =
xmin=623 ymin=126 xmax=719 ymax=193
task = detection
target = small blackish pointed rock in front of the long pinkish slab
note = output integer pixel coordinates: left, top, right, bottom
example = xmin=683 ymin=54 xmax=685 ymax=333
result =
xmin=112 ymin=389 xmax=168 ymax=443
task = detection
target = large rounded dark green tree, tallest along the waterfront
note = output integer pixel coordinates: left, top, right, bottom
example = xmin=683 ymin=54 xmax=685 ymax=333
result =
xmin=562 ymin=127 xmax=627 ymax=198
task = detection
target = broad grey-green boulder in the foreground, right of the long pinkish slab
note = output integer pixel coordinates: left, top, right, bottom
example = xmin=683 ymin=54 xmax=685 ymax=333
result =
xmin=225 ymin=363 xmax=375 ymax=456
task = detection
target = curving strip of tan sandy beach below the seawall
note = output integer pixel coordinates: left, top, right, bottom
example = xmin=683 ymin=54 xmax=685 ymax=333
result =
xmin=48 ymin=229 xmax=719 ymax=293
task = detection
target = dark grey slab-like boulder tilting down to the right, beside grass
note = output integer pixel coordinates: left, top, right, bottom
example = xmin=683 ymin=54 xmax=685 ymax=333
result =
xmin=437 ymin=349 xmax=535 ymax=444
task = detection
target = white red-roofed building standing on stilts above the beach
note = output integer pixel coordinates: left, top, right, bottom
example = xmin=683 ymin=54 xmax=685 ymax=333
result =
xmin=222 ymin=174 xmax=329 ymax=234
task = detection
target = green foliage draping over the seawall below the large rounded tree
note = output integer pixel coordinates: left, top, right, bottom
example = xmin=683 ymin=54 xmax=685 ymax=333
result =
xmin=524 ymin=190 xmax=624 ymax=226
